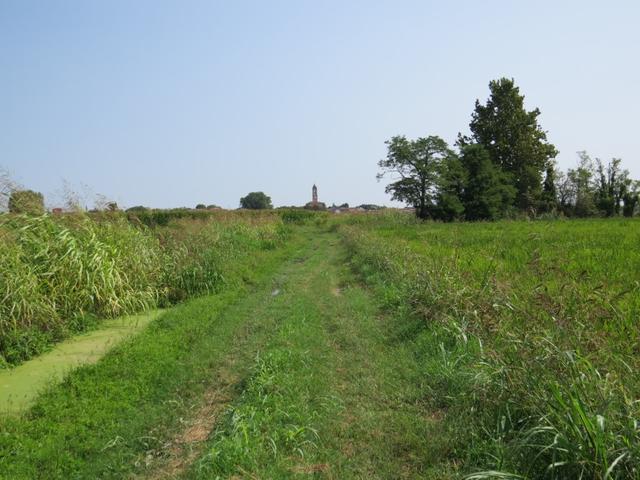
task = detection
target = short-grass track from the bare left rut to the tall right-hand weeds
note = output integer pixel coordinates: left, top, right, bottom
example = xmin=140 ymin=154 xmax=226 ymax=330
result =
xmin=180 ymin=233 xmax=445 ymax=479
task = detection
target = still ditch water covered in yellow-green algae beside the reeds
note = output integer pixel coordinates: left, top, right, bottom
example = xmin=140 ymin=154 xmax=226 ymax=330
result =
xmin=0 ymin=310 xmax=162 ymax=415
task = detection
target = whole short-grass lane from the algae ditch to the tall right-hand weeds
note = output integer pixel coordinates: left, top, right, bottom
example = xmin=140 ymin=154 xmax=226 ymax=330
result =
xmin=0 ymin=229 xmax=446 ymax=479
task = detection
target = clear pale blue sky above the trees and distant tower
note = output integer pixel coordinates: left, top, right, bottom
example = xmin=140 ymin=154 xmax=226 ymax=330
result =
xmin=0 ymin=0 xmax=640 ymax=207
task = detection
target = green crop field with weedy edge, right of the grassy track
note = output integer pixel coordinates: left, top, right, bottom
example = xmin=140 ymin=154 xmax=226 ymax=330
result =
xmin=334 ymin=215 xmax=640 ymax=478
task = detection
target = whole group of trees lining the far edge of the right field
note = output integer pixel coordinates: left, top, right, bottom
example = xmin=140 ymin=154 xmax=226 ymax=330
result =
xmin=378 ymin=78 xmax=640 ymax=221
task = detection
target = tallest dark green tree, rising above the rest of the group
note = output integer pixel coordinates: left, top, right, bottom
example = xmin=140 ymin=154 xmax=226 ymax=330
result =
xmin=458 ymin=78 xmax=558 ymax=210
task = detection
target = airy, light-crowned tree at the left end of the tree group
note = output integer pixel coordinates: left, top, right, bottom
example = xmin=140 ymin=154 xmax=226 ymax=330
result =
xmin=378 ymin=135 xmax=455 ymax=219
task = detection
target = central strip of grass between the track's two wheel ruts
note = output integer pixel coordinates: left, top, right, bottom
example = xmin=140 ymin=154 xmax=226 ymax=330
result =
xmin=187 ymin=232 xmax=335 ymax=479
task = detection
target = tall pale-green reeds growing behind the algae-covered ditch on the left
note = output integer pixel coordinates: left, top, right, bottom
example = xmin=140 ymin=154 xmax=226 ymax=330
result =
xmin=0 ymin=214 xmax=285 ymax=367
